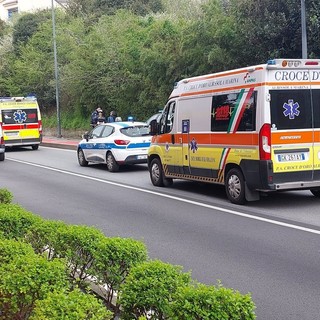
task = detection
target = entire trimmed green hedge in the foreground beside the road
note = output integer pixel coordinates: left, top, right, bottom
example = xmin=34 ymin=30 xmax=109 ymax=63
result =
xmin=0 ymin=189 xmax=255 ymax=320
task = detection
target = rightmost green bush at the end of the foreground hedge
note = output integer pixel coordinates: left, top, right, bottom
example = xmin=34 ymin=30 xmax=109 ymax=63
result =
xmin=170 ymin=284 xmax=256 ymax=320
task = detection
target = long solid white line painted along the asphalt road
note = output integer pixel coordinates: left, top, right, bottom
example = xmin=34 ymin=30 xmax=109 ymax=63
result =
xmin=6 ymin=158 xmax=320 ymax=235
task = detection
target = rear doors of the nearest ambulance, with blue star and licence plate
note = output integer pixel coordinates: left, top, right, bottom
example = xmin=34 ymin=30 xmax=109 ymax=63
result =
xmin=269 ymin=62 xmax=320 ymax=187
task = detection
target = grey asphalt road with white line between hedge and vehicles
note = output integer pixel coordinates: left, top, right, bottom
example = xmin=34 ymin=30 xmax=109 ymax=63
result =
xmin=0 ymin=147 xmax=320 ymax=320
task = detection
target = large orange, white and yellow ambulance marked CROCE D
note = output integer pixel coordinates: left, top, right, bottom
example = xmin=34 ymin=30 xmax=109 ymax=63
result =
xmin=148 ymin=59 xmax=320 ymax=204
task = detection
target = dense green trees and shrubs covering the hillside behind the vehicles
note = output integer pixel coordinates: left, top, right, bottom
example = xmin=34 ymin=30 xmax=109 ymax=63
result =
xmin=0 ymin=0 xmax=320 ymax=129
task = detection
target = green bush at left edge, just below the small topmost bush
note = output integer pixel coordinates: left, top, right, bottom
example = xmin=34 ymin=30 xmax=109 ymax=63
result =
xmin=0 ymin=204 xmax=41 ymax=240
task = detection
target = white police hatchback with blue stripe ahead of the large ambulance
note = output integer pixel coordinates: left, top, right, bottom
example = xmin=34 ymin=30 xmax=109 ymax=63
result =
xmin=77 ymin=121 xmax=151 ymax=172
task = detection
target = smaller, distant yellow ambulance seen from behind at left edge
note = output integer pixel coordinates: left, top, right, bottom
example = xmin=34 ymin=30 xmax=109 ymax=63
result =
xmin=0 ymin=97 xmax=42 ymax=150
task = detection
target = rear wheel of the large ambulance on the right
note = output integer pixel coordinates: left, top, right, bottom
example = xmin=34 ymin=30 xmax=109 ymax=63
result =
xmin=225 ymin=168 xmax=246 ymax=204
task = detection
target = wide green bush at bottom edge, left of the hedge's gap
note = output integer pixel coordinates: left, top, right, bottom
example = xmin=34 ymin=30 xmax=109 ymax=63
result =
xmin=29 ymin=289 xmax=112 ymax=320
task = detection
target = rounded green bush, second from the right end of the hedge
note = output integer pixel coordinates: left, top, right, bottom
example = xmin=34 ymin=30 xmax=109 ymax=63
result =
xmin=120 ymin=260 xmax=191 ymax=320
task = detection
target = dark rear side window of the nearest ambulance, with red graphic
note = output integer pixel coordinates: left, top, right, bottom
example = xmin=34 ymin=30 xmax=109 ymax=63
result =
xmin=211 ymin=92 xmax=257 ymax=132
